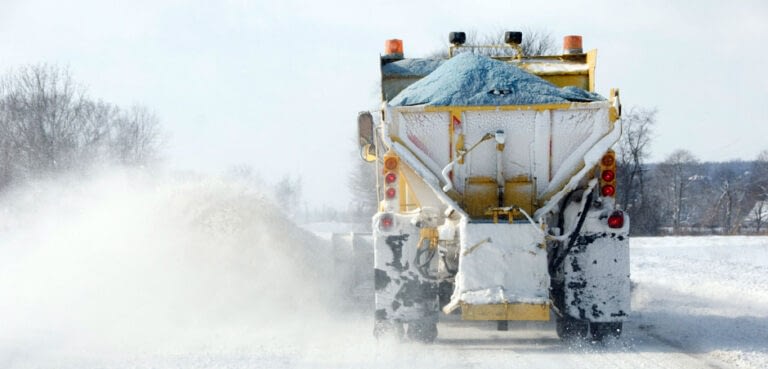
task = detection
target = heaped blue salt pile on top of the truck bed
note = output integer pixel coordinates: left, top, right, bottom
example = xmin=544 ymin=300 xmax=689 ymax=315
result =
xmin=390 ymin=53 xmax=604 ymax=106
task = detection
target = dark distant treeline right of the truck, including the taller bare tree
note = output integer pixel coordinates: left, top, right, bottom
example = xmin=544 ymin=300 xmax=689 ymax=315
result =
xmin=617 ymin=109 xmax=768 ymax=235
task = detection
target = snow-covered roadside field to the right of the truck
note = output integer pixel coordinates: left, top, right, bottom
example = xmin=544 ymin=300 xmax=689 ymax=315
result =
xmin=631 ymin=236 xmax=768 ymax=368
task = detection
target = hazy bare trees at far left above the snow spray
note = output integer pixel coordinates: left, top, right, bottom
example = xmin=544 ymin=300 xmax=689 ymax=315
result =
xmin=0 ymin=65 xmax=162 ymax=191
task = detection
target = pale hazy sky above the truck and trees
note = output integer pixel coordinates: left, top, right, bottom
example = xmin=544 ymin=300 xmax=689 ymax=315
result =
xmin=0 ymin=0 xmax=768 ymax=208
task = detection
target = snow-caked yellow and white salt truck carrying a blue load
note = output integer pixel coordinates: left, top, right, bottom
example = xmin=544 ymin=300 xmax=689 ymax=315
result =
xmin=358 ymin=32 xmax=630 ymax=342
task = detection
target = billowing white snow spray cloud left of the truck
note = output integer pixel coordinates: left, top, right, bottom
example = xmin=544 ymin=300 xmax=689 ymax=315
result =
xmin=0 ymin=170 xmax=342 ymax=356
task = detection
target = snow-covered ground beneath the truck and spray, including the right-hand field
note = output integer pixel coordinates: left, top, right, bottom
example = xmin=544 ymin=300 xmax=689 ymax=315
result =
xmin=0 ymin=237 xmax=768 ymax=369
